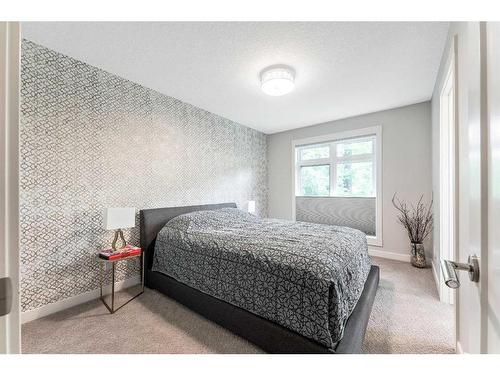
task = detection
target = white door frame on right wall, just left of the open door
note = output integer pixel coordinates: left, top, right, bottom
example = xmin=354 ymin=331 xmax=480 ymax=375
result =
xmin=438 ymin=36 xmax=459 ymax=304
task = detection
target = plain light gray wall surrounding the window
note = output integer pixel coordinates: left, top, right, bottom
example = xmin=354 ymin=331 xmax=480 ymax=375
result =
xmin=268 ymin=102 xmax=432 ymax=260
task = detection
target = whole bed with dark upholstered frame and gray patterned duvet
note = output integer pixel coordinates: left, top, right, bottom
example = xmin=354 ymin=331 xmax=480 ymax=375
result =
xmin=140 ymin=203 xmax=379 ymax=354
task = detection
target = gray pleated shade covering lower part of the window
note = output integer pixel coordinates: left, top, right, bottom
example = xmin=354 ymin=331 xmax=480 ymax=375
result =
xmin=295 ymin=197 xmax=376 ymax=236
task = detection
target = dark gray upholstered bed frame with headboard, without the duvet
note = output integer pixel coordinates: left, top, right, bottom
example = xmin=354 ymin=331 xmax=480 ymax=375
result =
xmin=140 ymin=203 xmax=380 ymax=354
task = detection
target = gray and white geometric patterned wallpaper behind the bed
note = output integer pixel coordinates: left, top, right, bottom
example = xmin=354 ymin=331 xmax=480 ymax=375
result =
xmin=20 ymin=40 xmax=267 ymax=311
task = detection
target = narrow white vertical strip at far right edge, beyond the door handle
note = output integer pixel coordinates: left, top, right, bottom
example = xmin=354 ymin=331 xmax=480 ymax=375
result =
xmin=485 ymin=22 xmax=500 ymax=353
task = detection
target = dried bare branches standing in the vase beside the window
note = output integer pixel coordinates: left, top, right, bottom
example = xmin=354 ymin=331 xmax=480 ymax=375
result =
xmin=392 ymin=193 xmax=433 ymax=243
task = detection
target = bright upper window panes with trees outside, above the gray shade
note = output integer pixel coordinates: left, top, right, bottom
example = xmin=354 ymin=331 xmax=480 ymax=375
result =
xmin=296 ymin=135 xmax=376 ymax=197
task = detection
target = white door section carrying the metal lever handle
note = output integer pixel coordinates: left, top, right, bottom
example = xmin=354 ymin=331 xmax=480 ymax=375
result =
xmin=456 ymin=22 xmax=486 ymax=353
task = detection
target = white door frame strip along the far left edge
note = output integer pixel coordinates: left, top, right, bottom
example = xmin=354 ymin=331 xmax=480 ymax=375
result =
xmin=0 ymin=22 xmax=21 ymax=353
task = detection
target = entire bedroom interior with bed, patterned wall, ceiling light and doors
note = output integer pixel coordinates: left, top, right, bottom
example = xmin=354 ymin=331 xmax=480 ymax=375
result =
xmin=0 ymin=0 xmax=500 ymax=370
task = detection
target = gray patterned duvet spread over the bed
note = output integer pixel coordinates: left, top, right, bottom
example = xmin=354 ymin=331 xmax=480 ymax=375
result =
xmin=153 ymin=208 xmax=370 ymax=348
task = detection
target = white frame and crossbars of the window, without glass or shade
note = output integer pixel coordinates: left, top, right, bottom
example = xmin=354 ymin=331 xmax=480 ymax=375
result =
xmin=291 ymin=125 xmax=383 ymax=246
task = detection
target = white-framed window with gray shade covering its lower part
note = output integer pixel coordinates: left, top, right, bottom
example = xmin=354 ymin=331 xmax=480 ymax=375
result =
xmin=291 ymin=126 xmax=383 ymax=246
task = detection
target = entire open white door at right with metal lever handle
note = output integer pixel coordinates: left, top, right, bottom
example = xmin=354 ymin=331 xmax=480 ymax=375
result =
xmin=457 ymin=22 xmax=500 ymax=353
